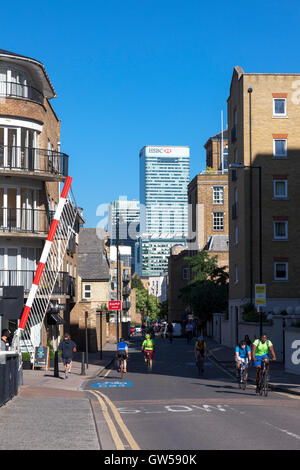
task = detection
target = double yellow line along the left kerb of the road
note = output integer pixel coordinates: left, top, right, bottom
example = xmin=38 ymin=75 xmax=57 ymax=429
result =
xmin=89 ymin=390 xmax=140 ymax=450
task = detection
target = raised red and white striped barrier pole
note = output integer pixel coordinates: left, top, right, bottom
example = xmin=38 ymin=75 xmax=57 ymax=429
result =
xmin=18 ymin=176 xmax=72 ymax=330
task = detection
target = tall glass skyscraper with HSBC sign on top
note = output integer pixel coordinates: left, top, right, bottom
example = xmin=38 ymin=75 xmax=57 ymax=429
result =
xmin=139 ymin=145 xmax=190 ymax=276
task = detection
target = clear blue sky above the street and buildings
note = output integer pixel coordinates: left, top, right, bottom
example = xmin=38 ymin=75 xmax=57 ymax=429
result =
xmin=0 ymin=0 xmax=300 ymax=227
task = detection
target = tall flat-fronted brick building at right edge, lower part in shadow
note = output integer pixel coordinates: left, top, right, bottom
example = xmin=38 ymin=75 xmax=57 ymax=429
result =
xmin=228 ymin=67 xmax=300 ymax=343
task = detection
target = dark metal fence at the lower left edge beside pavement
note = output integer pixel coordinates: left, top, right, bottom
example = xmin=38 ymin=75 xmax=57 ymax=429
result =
xmin=0 ymin=352 xmax=19 ymax=406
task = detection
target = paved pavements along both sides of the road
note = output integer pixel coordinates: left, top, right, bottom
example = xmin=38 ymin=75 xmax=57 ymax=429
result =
xmin=0 ymin=339 xmax=300 ymax=450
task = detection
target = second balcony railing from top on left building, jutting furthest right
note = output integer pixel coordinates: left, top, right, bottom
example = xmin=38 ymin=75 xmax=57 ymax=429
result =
xmin=0 ymin=143 xmax=69 ymax=176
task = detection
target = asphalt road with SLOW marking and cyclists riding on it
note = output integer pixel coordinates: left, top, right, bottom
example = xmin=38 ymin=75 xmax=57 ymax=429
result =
xmin=85 ymin=338 xmax=300 ymax=450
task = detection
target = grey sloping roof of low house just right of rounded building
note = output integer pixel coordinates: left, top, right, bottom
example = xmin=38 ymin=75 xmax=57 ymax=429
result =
xmin=78 ymin=228 xmax=109 ymax=281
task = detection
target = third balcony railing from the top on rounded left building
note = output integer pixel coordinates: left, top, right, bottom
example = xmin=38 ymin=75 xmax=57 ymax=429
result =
xmin=0 ymin=207 xmax=54 ymax=233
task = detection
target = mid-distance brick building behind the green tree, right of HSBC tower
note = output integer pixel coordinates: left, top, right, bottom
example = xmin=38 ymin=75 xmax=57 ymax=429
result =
xmin=168 ymin=130 xmax=229 ymax=321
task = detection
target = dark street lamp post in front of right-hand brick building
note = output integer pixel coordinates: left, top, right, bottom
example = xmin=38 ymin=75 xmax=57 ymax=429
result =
xmin=229 ymin=163 xmax=263 ymax=336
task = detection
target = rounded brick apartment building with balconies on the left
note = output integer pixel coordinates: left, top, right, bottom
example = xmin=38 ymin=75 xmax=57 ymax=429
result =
xmin=0 ymin=49 xmax=82 ymax=344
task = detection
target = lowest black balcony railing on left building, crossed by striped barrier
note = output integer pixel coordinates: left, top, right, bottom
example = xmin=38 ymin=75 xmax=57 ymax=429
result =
xmin=0 ymin=269 xmax=75 ymax=297
